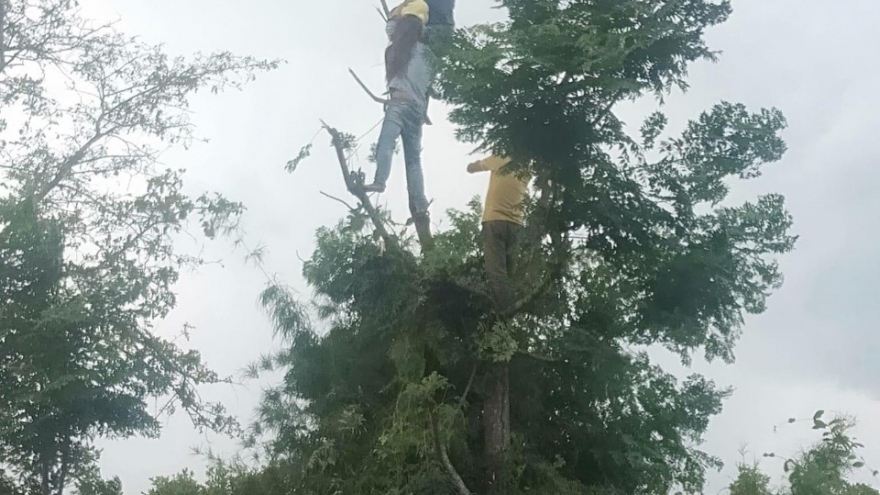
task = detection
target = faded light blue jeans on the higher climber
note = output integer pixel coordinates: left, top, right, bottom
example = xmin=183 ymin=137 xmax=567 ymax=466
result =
xmin=373 ymin=99 xmax=428 ymax=217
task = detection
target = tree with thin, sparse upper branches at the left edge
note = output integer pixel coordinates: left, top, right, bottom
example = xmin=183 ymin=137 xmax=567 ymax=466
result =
xmin=0 ymin=0 xmax=276 ymax=495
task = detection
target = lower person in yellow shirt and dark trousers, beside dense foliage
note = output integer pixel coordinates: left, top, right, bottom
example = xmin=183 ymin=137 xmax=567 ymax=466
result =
xmin=467 ymin=156 xmax=529 ymax=315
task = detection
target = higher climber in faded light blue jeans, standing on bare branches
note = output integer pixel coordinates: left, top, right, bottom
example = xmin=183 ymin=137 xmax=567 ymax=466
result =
xmin=364 ymin=0 xmax=434 ymax=247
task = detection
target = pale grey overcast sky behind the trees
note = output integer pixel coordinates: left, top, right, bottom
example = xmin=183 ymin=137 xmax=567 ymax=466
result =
xmin=74 ymin=0 xmax=880 ymax=494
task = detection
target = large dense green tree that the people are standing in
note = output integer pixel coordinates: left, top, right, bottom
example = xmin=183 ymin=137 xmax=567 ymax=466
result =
xmin=242 ymin=0 xmax=795 ymax=495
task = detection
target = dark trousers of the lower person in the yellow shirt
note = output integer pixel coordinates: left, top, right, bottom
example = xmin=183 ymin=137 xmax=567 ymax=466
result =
xmin=483 ymin=220 xmax=522 ymax=314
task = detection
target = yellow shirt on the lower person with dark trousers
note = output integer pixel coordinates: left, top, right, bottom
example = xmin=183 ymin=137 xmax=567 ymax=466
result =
xmin=468 ymin=156 xmax=529 ymax=225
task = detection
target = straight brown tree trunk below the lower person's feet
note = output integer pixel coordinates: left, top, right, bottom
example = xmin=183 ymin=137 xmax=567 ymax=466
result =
xmin=483 ymin=363 xmax=510 ymax=495
